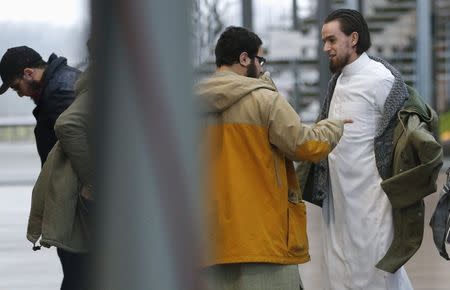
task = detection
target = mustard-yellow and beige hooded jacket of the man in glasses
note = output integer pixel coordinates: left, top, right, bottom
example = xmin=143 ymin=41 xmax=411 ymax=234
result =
xmin=199 ymin=72 xmax=340 ymax=265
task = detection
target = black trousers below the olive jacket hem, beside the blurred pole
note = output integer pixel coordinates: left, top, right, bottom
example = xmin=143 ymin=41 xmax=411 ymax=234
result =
xmin=57 ymin=248 xmax=90 ymax=290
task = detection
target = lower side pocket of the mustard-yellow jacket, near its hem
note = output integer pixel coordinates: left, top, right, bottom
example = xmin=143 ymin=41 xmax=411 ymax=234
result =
xmin=287 ymin=202 xmax=308 ymax=256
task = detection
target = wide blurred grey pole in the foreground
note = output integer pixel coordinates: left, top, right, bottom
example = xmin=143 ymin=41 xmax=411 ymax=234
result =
xmin=92 ymin=0 xmax=201 ymax=290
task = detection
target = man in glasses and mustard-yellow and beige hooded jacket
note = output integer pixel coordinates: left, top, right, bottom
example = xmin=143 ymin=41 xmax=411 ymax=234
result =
xmin=197 ymin=27 xmax=351 ymax=290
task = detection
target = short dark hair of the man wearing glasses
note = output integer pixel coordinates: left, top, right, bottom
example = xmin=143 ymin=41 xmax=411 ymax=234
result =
xmin=215 ymin=26 xmax=262 ymax=67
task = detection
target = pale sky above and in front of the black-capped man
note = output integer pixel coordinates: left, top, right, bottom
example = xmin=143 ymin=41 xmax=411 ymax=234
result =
xmin=0 ymin=0 xmax=90 ymax=121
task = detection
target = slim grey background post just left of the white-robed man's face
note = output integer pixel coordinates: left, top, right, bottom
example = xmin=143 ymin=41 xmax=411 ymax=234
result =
xmin=316 ymin=0 xmax=331 ymax=103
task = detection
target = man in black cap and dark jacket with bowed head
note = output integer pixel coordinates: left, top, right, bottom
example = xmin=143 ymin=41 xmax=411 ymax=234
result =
xmin=0 ymin=46 xmax=80 ymax=165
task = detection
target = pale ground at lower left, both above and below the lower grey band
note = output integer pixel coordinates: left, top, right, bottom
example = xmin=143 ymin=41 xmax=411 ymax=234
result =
xmin=0 ymin=143 xmax=62 ymax=290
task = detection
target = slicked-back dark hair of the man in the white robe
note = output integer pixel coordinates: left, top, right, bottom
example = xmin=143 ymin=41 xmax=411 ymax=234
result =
xmin=324 ymin=9 xmax=372 ymax=55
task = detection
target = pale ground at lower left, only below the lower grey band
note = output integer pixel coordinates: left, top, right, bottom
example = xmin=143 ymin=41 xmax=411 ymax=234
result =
xmin=0 ymin=186 xmax=62 ymax=290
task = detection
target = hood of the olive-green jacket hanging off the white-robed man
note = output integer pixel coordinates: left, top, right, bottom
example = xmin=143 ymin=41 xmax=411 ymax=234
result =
xmin=399 ymin=85 xmax=438 ymax=133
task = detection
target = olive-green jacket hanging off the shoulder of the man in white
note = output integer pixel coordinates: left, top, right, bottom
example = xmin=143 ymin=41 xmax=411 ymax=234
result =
xmin=376 ymin=86 xmax=442 ymax=273
